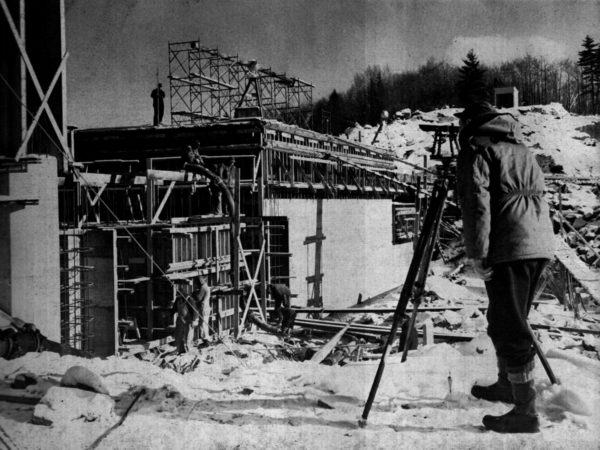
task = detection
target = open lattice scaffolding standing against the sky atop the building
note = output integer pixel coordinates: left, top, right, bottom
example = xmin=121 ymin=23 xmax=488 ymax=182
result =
xmin=169 ymin=41 xmax=313 ymax=128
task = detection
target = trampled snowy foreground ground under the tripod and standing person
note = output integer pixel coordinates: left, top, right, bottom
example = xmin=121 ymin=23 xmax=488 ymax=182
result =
xmin=0 ymin=326 xmax=600 ymax=449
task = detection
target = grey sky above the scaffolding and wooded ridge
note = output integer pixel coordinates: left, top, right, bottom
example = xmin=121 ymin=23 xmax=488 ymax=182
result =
xmin=65 ymin=0 xmax=600 ymax=128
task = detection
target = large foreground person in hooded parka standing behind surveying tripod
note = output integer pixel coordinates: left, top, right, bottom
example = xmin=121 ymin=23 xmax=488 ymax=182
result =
xmin=457 ymin=102 xmax=554 ymax=433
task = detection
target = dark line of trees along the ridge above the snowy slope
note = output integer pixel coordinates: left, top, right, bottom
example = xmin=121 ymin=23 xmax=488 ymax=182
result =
xmin=313 ymin=36 xmax=600 ymax=134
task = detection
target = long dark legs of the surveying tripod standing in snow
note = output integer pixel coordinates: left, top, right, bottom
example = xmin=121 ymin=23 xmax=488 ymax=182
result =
xmin=358 ymin=176 xmax=558 ymax=427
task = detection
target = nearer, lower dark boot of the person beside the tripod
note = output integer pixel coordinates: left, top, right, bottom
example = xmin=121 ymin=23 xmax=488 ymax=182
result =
xmin=483 ymin=378 xmax=540 ymax=433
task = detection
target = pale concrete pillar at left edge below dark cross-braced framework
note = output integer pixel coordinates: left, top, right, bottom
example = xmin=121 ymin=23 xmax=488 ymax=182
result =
xmin=0 ymin=156 xmax=60 ymax=341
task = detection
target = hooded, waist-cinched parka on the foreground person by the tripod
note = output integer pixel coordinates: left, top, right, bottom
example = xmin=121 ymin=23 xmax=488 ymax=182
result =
xmin=457 ymin=114 xmax=554 ymax=265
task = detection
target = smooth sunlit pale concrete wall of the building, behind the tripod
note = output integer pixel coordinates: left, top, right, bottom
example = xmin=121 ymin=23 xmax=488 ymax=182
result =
xmin=265 ymin=199 xmax=412 ymax=307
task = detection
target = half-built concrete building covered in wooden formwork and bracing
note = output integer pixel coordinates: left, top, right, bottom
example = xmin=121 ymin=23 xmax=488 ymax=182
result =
xmin=67 ymin=118 xmax=426 ymax=354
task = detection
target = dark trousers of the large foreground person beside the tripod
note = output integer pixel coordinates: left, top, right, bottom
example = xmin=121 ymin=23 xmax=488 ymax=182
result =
xmin=485 ymin=259 xmax=548 ymax=368
